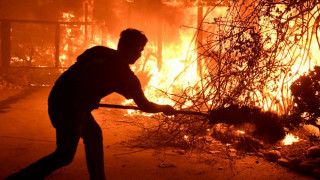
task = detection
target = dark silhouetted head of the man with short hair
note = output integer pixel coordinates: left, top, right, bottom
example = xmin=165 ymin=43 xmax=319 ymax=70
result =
xmin=118 ymin=29 xmax=148 ymax=64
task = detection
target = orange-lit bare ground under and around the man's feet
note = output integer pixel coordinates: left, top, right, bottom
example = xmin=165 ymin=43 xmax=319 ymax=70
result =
xmin=0 ymin=87 xmax=313 ymax=180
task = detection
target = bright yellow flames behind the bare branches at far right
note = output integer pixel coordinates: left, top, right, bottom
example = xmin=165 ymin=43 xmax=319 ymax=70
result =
xmin=260 ymin=3 xmax=320 ymax=114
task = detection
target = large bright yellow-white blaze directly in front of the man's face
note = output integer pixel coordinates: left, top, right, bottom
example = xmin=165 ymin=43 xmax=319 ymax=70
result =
xmin=145 ymin=30 xmax=199 ymax=105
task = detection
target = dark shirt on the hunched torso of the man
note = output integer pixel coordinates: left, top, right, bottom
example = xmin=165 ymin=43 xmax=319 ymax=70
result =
xmin=49 ymin=46 xmax=144 ymax=111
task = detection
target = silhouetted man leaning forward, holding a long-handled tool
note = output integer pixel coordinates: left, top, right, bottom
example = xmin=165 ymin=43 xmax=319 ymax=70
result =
xmin=8 ymin=29 xmax=174 ymax=180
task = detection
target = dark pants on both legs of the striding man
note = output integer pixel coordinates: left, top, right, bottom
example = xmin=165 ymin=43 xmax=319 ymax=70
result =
xmin=7 ymin=107 xmax=105 ymax=180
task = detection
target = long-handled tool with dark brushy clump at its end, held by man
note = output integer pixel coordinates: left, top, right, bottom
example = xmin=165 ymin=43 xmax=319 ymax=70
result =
xmin=99 ymin=104 xmax=285 ymax=144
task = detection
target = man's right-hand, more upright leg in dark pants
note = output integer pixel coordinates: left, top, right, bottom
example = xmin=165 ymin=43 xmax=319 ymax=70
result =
xmin=81 ymin=113 xmax=106 ymax=180
